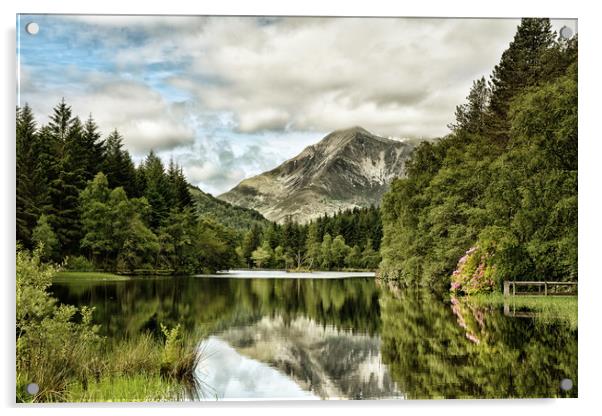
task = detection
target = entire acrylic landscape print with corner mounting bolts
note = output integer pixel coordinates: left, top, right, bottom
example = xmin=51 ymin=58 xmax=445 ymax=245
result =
xmin=16 ymin=15 xmax=578 ymax=402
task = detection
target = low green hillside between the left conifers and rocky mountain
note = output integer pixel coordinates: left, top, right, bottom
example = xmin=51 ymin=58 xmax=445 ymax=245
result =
xmin=189 ymin=185 xmax=268 ymax=230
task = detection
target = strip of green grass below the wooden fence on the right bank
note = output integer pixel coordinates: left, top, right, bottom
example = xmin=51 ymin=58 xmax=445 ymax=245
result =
xmin=470 ymin=293 xmax=578 ymax=330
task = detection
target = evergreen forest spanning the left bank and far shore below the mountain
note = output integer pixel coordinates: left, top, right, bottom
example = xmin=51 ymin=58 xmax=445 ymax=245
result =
xmin=17 ymin=100 xmax=382 ymax=274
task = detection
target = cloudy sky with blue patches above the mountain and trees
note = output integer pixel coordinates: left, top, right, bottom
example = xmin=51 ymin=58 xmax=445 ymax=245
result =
xmin=18 ymin=15 xmax=576 ymax=194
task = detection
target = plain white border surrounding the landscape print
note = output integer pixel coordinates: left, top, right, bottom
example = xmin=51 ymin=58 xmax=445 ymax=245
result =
xmin=0 ymin=0 xmax=602 ymax=416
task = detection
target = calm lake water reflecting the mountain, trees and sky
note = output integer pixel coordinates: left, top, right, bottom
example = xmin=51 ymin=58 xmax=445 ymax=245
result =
xmin=52 ymin=272 xmax=577 ymax=400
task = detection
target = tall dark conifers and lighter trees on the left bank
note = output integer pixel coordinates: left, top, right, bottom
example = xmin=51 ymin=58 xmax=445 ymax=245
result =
xmin=16 ymin=100 xmax=237 ymax=272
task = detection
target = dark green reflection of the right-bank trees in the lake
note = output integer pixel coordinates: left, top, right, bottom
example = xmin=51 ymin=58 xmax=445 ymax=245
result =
xmin=380 ymin=290 xmax=578 ymax=399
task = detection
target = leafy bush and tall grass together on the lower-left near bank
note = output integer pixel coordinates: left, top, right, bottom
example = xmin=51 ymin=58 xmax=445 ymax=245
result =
xmin=16 ymin=250 xmax=200 ymax=402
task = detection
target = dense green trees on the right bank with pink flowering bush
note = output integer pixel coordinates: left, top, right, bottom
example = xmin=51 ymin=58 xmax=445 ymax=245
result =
xmin=381 ymin=19 xmax=577 ymax=293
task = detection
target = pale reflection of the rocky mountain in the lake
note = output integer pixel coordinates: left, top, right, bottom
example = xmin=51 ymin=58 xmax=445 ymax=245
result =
xmin=216 ymin=316 xmax=401 ymax=399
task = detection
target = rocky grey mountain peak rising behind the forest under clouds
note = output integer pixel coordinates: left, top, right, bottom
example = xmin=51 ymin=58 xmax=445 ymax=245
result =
xmin=218 ymin=127 xmax=414 ymax=223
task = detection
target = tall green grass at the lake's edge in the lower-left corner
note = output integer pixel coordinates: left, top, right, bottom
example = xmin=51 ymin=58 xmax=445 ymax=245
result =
xmin=17 ymin=332 xmax=200 ymax=403
